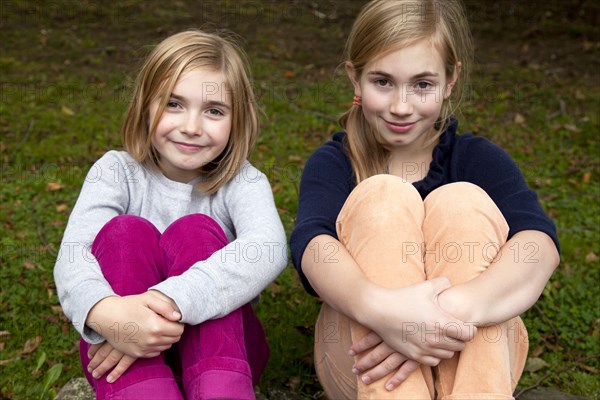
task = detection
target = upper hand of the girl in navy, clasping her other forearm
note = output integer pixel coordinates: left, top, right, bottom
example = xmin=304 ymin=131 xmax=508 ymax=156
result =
xmin=364 ymin=277 xmax=476 ymax=366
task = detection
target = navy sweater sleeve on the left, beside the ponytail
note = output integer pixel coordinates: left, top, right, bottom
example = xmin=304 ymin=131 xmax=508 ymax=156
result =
xmin=290 ymin=141 xmax=354 ymax=296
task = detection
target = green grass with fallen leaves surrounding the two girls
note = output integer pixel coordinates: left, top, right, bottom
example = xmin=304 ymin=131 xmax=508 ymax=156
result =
xmin=0 ymin=0 xmax=600 ymax=399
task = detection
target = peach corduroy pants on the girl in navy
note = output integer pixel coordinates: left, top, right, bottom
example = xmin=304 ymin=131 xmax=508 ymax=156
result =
xmin=315 ymin=175 xmax=528 ymax=400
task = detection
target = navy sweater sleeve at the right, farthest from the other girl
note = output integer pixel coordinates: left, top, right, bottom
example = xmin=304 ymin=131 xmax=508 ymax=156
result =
xmin=460 ymin=136 xmax=560 ymax=251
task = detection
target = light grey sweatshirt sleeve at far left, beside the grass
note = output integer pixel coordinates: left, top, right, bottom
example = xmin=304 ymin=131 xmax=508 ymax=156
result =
xmin=54 ymin=152 xmax=129 ymax=343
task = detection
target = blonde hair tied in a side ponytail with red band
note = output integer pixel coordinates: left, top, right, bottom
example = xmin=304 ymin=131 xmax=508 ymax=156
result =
xmin=340 ymin=0 xmax=472 ymax=183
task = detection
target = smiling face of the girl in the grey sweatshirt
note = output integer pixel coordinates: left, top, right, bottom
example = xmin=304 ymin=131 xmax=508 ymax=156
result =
xmin=150 ymin=68 xmax=232 ymax=183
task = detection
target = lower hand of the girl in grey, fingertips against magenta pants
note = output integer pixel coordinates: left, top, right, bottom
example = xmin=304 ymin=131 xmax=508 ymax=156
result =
xmin=87 ymin=342 xmax=137 ymax=383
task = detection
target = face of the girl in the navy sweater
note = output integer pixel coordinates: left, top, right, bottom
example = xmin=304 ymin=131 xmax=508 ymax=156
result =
xmin=346 ymin=40 xmax=456 ymax=152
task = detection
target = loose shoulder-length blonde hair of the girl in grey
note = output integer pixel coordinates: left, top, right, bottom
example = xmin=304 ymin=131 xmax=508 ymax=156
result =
xmin=122 ymin=30 xmax=259 ymax=194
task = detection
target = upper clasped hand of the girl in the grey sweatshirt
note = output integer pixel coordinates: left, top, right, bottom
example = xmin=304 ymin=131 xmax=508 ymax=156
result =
xmin=86 ymin=291 xmax=184 ymax=358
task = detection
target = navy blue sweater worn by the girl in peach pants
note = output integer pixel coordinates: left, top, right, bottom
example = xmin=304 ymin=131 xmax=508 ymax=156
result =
xmin=290 ymin=121 xmax=559 ymax=296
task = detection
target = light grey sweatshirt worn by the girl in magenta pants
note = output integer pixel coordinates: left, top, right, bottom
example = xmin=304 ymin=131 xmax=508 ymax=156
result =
xmin=54 ymin=151 xmax=287 ymax=343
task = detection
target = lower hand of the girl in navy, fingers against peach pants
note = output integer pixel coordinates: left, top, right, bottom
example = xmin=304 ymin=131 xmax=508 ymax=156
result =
xmin=350 ymin=332 xmax=419 ymax=391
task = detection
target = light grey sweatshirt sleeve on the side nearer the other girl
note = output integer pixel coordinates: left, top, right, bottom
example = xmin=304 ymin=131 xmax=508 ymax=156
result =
xmin=151 ymin=163 xmax=287 ymax=325
